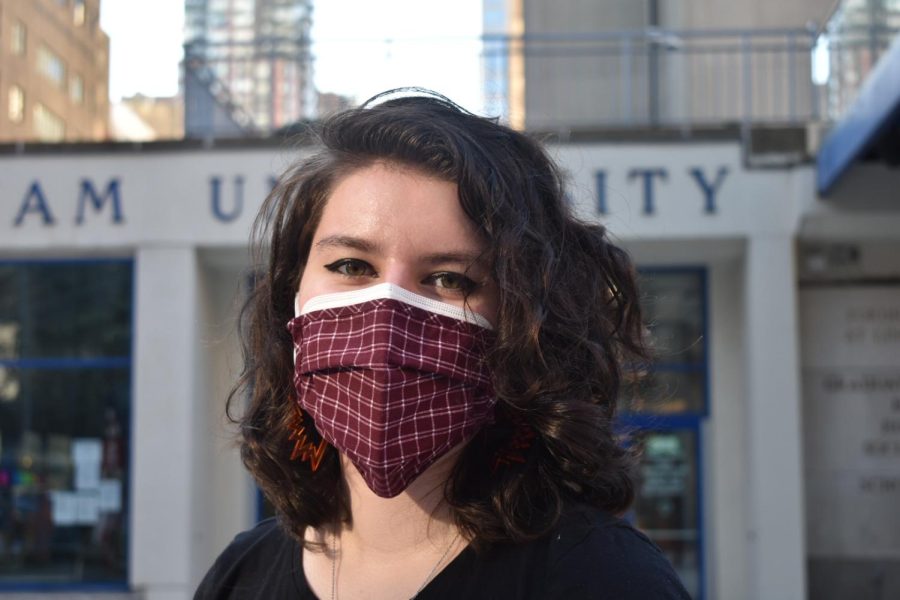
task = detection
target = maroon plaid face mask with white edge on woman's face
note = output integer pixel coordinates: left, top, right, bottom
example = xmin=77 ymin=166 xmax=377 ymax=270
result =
xmin=288 ymin=283 xmax=495 ymax=498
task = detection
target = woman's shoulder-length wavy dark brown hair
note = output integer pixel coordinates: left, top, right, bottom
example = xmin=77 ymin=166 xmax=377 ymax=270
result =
xmin=229 ymin=93 xmax=646 ymax=545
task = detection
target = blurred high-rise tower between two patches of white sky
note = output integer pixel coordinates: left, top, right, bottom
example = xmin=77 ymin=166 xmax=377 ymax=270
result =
xmin=184 ymin=0 xmax=316 ymax=136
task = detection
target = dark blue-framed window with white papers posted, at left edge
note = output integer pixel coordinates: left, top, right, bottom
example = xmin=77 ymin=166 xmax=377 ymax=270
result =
xmin=0 ymin=261 xmax=132 ymax=589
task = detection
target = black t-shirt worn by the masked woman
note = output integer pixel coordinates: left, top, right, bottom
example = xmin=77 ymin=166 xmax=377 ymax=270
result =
xmin=194 ymin=507 xmax=689 ymax=600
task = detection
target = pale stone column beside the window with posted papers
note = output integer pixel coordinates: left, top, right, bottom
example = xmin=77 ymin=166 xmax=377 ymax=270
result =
xmin=129 ymin=247 xmax=202 ymax=600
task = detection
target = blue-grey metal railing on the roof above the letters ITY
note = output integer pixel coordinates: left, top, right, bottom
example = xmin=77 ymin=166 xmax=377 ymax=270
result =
xmin=484 ymin=28 xmax=824 ymax=130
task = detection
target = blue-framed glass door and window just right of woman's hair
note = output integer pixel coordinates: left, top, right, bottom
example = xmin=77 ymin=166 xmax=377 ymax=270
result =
xmin=619 ymin=269 xmax=708 ymax=599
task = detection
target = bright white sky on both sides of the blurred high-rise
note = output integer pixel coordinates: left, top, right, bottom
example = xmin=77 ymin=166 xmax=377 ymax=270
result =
xmin=100 ymin=0 xmax=482 ymax=111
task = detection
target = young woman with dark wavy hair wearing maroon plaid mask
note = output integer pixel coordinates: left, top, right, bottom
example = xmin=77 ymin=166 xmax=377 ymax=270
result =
xmin=196 ymin=94 xmax=687 ymax=600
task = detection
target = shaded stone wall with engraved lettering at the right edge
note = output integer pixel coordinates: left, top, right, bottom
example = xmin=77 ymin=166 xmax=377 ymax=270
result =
xmin=800 ymin=240 xmax=900 ymax=600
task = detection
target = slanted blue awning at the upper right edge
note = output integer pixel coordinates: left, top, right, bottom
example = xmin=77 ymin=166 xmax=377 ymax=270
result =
xmin=817 ymin=36 xmax=900 ymax=195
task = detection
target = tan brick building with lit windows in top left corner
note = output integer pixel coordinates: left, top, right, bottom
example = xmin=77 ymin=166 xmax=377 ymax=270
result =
xmin=0 ymin=0 xmax=109 ymax=142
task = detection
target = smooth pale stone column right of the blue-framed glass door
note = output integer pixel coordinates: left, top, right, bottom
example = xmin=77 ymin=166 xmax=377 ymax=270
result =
xmin=744 ymin=235 xmax=806 ymax=600
